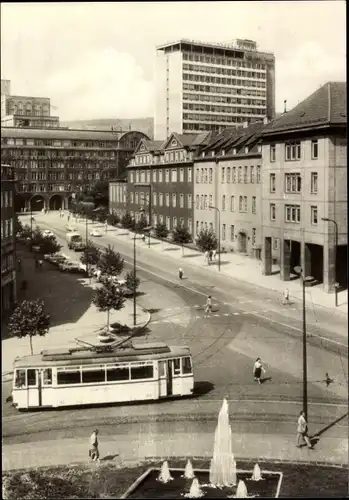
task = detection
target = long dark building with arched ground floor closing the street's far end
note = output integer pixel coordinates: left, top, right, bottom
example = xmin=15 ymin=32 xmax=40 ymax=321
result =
xmin=1 ymin=127 xmax=147 ymax=211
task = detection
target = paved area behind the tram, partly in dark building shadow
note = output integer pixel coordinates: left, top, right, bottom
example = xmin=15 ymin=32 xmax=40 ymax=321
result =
xmin=1 ymin=244 xmax=151 ymax=375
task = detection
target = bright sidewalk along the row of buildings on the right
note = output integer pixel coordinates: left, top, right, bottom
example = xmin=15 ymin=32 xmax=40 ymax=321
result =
xmin=109 ymin=227 xmax=348 ymax=316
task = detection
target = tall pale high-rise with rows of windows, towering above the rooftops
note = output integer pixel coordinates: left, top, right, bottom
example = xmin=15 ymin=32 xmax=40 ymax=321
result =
xmin=154 ymin=40 xmax=275 ymax=140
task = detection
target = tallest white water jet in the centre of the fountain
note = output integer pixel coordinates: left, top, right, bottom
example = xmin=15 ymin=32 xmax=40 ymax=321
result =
xmin=209 ymin=399 xmax=236 ymax=487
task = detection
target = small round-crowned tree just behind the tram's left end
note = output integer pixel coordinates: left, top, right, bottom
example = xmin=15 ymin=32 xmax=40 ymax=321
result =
xmin=8 ymin=299 xmax=50 ymax=354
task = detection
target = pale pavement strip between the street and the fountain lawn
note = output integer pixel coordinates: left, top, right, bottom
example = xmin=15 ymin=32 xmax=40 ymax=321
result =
xmin=2 ymin=431 xmax=348 ymax=470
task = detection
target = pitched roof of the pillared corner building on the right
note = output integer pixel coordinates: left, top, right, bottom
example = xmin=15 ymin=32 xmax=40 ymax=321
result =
xmin=263 ymin=82 xmax=347 ymax=135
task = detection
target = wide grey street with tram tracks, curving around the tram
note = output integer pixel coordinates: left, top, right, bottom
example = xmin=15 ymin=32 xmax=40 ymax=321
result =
xmin=3 ymin=214 xmax=348 ymax=454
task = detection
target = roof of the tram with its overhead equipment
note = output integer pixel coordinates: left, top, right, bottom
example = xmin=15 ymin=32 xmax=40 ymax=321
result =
xmin=14 ymin=342 xmax=190 ymax=368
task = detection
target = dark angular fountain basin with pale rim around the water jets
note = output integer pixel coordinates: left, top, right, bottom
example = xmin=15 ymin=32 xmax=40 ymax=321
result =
xmin=121 ymin=467 xmax=282 ymax=499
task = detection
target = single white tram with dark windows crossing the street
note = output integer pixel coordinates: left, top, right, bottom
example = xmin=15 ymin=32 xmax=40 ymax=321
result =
xmin=12 ymin=341 xmax=194 ymax=410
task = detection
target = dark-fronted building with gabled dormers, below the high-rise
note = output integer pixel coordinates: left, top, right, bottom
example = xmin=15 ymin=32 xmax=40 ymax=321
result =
xmin=110 ymin=132 xmax=211 ymax=234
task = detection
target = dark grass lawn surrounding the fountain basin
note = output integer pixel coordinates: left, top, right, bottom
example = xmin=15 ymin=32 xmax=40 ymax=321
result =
xmin=3 ymin=459 xmax=348 ymax=500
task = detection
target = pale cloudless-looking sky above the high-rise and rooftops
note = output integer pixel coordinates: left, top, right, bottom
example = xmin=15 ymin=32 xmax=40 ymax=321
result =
xmin=1 ymin=0 xmax=346 ymax=120
